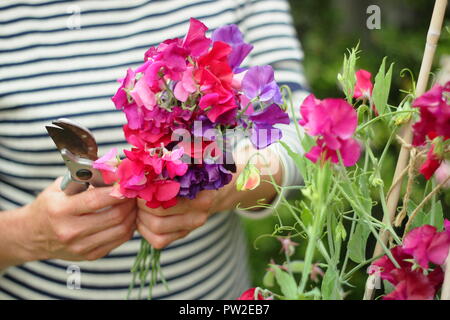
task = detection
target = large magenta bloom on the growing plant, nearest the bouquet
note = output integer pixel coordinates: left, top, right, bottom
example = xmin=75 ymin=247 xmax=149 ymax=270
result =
xmin=299 ymin=94 xmax=361 ymax=167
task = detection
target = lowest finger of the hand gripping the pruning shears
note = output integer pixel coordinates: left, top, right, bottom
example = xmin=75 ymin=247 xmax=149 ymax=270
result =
xmin=71 ymin=208 xmax=136 ymax=255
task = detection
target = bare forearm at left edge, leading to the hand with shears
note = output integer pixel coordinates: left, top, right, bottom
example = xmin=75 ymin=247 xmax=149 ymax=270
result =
xmin=0 ymin=208 xmax=33 ymax=270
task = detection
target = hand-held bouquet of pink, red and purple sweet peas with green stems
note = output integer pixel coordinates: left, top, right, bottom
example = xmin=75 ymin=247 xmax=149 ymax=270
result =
xmin=95 ymin=19 xmax=290 ymax=297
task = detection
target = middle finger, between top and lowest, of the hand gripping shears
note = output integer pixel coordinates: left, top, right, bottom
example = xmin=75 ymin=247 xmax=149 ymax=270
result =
xmin=75 ymin=199 xmax=137 ymax=237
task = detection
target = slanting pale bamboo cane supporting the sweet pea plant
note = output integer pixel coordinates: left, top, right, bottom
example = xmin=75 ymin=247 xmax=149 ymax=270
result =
xmin=364 ymin=0 xmax=450 ymax=300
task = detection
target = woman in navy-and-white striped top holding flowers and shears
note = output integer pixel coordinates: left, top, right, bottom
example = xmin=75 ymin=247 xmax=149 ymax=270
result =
xmin=0 ymin=0 xmax=304 ymax=299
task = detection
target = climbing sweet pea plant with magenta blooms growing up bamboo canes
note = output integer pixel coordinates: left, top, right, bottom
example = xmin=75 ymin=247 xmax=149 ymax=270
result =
xmin=241 ymin=48 xmax=450 ymax=300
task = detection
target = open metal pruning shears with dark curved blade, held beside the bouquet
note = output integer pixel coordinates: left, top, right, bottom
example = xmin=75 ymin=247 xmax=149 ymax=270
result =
xmin=45 ymin=118 xmax=107 ymax=195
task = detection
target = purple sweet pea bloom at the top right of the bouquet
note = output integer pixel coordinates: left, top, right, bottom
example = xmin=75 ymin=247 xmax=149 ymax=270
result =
xmin=212 ymin=24 xmax=253 ymax=73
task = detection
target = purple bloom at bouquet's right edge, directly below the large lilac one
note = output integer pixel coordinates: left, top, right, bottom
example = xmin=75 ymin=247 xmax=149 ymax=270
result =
xmin=249 ymin=103 xmax=290 ymax=150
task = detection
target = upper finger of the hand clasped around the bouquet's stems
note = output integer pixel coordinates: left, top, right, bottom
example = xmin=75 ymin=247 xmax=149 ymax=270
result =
xmin=137 ymin=211 xmax=208 ymax=234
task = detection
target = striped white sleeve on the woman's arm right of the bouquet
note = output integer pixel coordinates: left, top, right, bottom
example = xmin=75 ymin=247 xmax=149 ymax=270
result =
xmin=235 ymin=0 xmax=309 ymax=219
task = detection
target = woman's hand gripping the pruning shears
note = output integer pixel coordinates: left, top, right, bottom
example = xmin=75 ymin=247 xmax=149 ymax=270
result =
xmin=0 ymin=178 xmax=136 ymax=266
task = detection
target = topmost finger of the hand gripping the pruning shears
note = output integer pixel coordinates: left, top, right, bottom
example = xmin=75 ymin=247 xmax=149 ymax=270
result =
xmin=61 ymin=187 xmax=128 ymax=215
